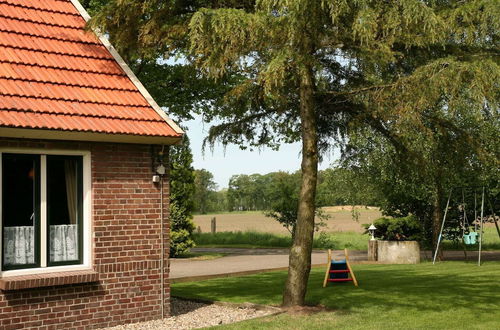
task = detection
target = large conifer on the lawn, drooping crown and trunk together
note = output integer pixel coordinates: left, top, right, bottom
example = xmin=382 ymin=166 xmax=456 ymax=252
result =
xmin=91 ymin=0 xmax=500 ymax=305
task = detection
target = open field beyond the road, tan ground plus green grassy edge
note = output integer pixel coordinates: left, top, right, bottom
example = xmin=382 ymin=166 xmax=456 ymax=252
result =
xmin=194 ymin=206 xmax=500 ymax=251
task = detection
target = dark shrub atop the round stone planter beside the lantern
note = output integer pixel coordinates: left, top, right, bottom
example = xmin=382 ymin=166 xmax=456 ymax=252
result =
xmin=363 ymin=215 xmax=422 ymax=241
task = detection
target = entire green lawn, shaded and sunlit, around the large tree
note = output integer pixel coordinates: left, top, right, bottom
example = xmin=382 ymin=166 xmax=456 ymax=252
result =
xmin=172 ymin=262 xmax=500 ymax=329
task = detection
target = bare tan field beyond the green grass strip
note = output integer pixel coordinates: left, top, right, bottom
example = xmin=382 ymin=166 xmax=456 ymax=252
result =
xmin=194 ymin=206 xmax=382 ymax=234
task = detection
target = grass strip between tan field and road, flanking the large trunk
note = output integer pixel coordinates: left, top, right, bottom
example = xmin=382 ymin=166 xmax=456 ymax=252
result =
xmin=194 ymin=231 xmax=368 ymax=250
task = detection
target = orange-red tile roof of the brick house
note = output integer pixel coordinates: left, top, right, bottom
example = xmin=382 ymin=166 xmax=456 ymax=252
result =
xmin=0 ymin=0 xmax=182 ymax=138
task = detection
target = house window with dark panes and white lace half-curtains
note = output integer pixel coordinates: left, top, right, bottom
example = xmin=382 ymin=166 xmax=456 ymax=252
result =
xmin=1 ymin=153 xmax=83 ymax=271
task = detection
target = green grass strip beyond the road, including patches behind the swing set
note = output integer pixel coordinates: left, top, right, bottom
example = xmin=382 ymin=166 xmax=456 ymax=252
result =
xmin=194 ymin=227 xmax=500 ymax=251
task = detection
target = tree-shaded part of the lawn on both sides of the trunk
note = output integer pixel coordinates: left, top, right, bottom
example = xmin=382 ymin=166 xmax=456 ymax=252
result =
xmin=173 ymin=262 xmax=500 ymax=313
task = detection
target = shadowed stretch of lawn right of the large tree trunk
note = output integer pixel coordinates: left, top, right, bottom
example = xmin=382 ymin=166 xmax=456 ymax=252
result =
xmin=308 ymin=263 xmax=500 ymax=313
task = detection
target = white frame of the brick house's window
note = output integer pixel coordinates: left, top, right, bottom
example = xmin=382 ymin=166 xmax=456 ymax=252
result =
xmin=0 ymin=148 xmax=92 ymax=278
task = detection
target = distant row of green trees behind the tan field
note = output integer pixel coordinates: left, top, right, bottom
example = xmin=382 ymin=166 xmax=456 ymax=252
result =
xmin=193 ymin=166 xmax=383 ymax=214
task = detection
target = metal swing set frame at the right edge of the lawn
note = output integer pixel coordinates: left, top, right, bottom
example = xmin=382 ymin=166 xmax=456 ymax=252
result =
xmin=432 ymin=186 xmax=500 ymax=266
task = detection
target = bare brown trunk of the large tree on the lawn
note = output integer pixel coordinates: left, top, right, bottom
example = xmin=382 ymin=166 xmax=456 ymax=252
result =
xmin=283 ymin=66 xmax=318 ymax=306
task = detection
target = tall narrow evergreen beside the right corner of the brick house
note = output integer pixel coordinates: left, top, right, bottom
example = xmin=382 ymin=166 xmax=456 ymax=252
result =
xmin=170 ymin=135 xmax=195 ymax=257
